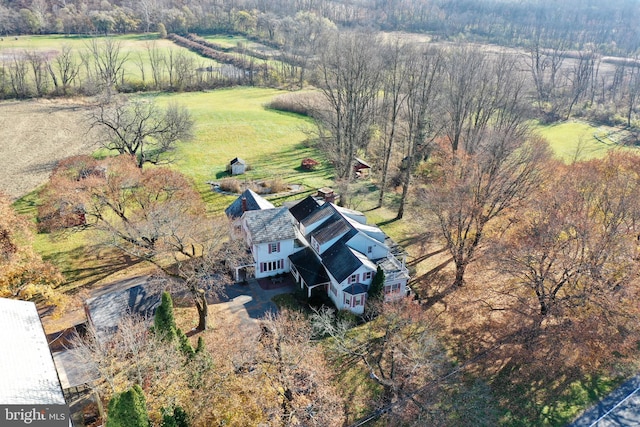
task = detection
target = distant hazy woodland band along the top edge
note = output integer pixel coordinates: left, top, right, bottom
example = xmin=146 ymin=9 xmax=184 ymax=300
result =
xmin=0 ymin=0 xmax=640 ymax=55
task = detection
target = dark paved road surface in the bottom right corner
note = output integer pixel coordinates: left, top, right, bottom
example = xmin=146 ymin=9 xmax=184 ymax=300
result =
xmin=569 ymin=375 xmax=640 ymax=427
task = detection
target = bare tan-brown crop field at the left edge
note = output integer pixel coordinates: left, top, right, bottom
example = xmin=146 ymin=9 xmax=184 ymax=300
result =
xmin=0 ymin=99 xmax=95 ymax=199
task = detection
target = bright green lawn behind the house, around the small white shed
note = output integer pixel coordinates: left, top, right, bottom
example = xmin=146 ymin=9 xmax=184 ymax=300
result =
xmin=141 ymin=88 xmax=333 ymax=212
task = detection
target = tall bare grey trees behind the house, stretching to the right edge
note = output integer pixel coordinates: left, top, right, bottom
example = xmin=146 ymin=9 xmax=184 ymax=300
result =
xmin=290 ymin=31 xmax=640 ymax=218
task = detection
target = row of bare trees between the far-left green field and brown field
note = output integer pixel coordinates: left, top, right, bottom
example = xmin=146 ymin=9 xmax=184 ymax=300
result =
xmin=0 ymin=38 xmax=264 ymax=99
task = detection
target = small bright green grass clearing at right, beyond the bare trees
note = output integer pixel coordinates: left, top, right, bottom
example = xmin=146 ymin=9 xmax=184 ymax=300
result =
xmin=535 ymin=121 xmax=619 ymax=162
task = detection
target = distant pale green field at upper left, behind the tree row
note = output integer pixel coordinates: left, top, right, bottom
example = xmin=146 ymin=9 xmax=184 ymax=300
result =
xmin=0 ymin=33 xmax=225 ymax=87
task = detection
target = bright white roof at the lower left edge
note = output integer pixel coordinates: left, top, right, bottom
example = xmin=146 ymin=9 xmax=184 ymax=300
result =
xmin=0 ymin=298 xmax=65 ymax=405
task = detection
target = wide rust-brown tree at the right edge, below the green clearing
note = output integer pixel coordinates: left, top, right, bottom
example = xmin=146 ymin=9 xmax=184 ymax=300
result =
xmin=496 ymin=153 xmax=640 ymax=318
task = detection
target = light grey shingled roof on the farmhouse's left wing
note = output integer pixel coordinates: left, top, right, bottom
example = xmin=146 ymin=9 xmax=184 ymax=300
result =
xmin=243 ymin=208 xmax=296 ymax=243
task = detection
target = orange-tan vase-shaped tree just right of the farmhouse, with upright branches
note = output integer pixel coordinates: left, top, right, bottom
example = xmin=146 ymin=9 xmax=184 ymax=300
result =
xmin=421 ymin=132 xmax=549 ymax=286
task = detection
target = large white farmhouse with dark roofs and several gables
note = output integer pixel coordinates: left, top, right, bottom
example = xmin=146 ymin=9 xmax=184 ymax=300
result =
xmin=230 ymin=195 xmax=409 ymax=314
